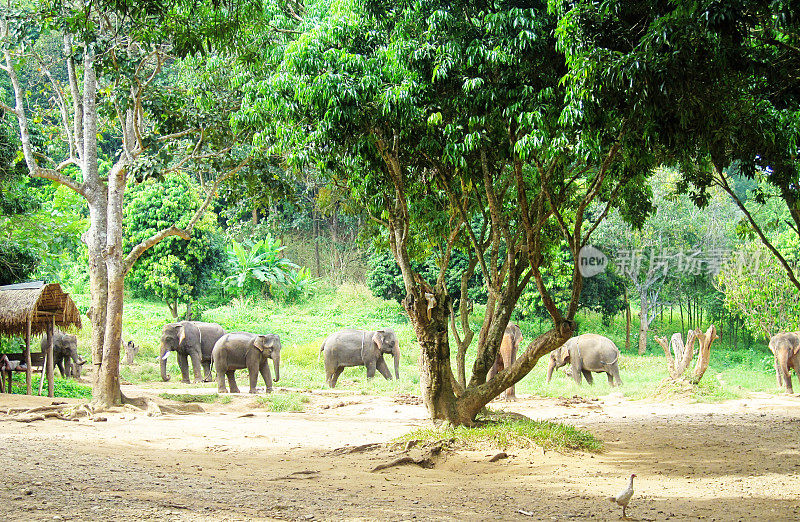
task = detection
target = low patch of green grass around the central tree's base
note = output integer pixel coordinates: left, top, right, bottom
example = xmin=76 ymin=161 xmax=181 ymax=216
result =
xmin=398 ymin=419 xmax=603 ymax=452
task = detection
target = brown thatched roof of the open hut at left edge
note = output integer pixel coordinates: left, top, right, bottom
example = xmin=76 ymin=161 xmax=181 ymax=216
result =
xmin=0 ymin=281 xmax=81 ymax=336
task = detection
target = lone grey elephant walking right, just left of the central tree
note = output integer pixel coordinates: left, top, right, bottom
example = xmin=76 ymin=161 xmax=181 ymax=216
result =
xmin=319 ymin=328 xmax=400 ymax=388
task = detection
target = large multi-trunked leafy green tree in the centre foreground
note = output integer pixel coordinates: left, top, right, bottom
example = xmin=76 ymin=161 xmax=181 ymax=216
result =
xmin=248 ymin=1 xmax=649 ymax=424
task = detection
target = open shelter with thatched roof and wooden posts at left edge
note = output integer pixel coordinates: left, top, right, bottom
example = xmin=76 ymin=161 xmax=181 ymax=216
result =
xmin=0 ymin=281 xmax=81 ymax=397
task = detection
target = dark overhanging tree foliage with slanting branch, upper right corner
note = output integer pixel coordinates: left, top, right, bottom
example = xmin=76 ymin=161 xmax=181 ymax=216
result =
xmin=554 ymin=0 xmax=800 ymax=288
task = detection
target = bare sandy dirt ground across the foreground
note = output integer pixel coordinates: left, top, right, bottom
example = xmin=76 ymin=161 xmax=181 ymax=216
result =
xmin=0 ymin=386 xmax=800 ymax=521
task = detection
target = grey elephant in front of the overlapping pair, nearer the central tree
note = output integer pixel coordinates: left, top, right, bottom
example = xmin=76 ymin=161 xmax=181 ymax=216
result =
xmin=212 ymin=332 xmax=281 ymax=393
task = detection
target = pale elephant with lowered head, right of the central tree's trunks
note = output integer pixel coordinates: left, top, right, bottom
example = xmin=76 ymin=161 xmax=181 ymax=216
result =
xmin=547 ymin=334 xmax=622 ymax=386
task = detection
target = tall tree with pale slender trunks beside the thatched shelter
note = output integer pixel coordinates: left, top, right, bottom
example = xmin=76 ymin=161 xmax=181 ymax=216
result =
xmin=0 ymin=0 xmax=256 ymax=406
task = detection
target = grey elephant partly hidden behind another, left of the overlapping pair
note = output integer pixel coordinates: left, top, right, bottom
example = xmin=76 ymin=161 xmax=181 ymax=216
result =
xmin=159 ymin=321 xmax=225 ymax=384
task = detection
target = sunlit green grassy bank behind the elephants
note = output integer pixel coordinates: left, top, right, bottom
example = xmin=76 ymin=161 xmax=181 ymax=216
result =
xmin=57 ymin=285 xmax=778 ymax=401
